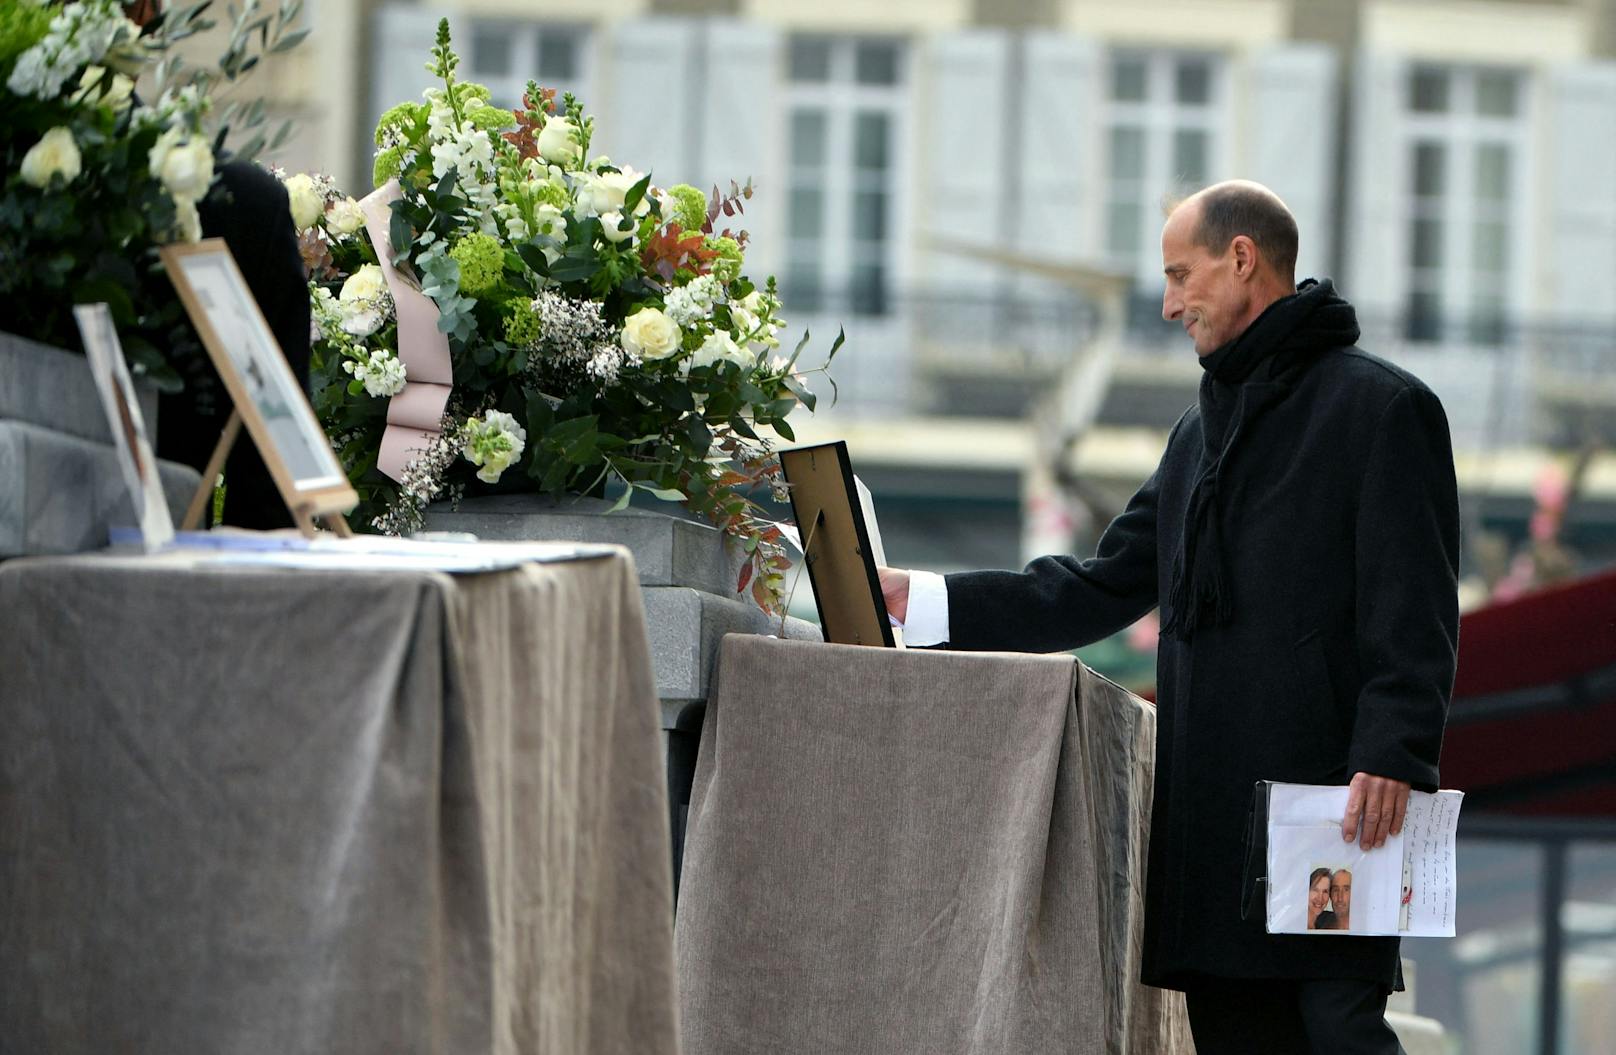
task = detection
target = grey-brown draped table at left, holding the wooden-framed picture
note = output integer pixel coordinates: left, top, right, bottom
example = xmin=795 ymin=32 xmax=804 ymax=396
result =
xmin=0 ymin=549 xmax=677 ymax=1055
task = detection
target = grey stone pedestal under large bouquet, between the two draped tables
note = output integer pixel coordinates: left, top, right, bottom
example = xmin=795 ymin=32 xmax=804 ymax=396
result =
xmin=425 ymin=494 xmax=824 ymax=895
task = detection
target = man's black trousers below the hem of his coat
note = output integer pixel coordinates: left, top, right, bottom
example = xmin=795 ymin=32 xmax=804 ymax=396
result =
xmin=1185 ymin=979 xmax=1403 ymax=1055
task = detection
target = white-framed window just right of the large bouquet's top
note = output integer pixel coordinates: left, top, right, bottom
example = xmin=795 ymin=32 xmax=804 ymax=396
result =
xmin=781 ymin=36 xmax=908 ymax=315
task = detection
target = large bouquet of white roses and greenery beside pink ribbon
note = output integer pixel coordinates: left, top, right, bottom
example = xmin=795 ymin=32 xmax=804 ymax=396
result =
xmin=295 ymin=21 xmax=842 ymax=611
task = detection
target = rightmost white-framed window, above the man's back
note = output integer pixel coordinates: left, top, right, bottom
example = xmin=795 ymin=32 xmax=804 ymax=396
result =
xmin=1403 ymin=65 xmax=1526 ymax=344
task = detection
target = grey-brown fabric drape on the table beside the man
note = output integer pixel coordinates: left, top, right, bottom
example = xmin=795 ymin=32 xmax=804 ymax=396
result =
xmin=675 ymin=637 xmax=1193 ymax=1055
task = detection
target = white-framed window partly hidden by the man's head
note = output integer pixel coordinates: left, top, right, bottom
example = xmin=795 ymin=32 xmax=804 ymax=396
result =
xmin=1102 ymin=50 xmax=1227 ymax=295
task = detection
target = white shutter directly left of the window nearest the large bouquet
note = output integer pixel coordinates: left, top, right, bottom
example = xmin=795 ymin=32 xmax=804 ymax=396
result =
xmin=687 ymin=18 xmax=785 ymax=281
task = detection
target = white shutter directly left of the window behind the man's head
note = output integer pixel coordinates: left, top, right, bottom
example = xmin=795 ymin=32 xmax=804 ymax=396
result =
xmin=1015 ymin=32 xmax=1102 ymax=263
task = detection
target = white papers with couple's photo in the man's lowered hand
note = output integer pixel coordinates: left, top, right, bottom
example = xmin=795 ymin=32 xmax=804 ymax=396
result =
xmin=1257 ymin=782 xmax=1464 ymax=937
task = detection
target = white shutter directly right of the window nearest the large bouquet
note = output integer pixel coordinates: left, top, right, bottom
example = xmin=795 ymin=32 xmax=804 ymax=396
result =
xmin=913 ymin=29 xmax=1012 ymax=291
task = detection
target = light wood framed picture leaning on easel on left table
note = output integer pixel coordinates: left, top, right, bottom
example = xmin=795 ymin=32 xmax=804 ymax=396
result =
xmin=162 ymin=237 xmax=359 ymax=520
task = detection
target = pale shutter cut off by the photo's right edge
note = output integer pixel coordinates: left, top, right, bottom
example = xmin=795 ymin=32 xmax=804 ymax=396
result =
xmin=1542 ymin=63 xmax=1616 ymax=323
